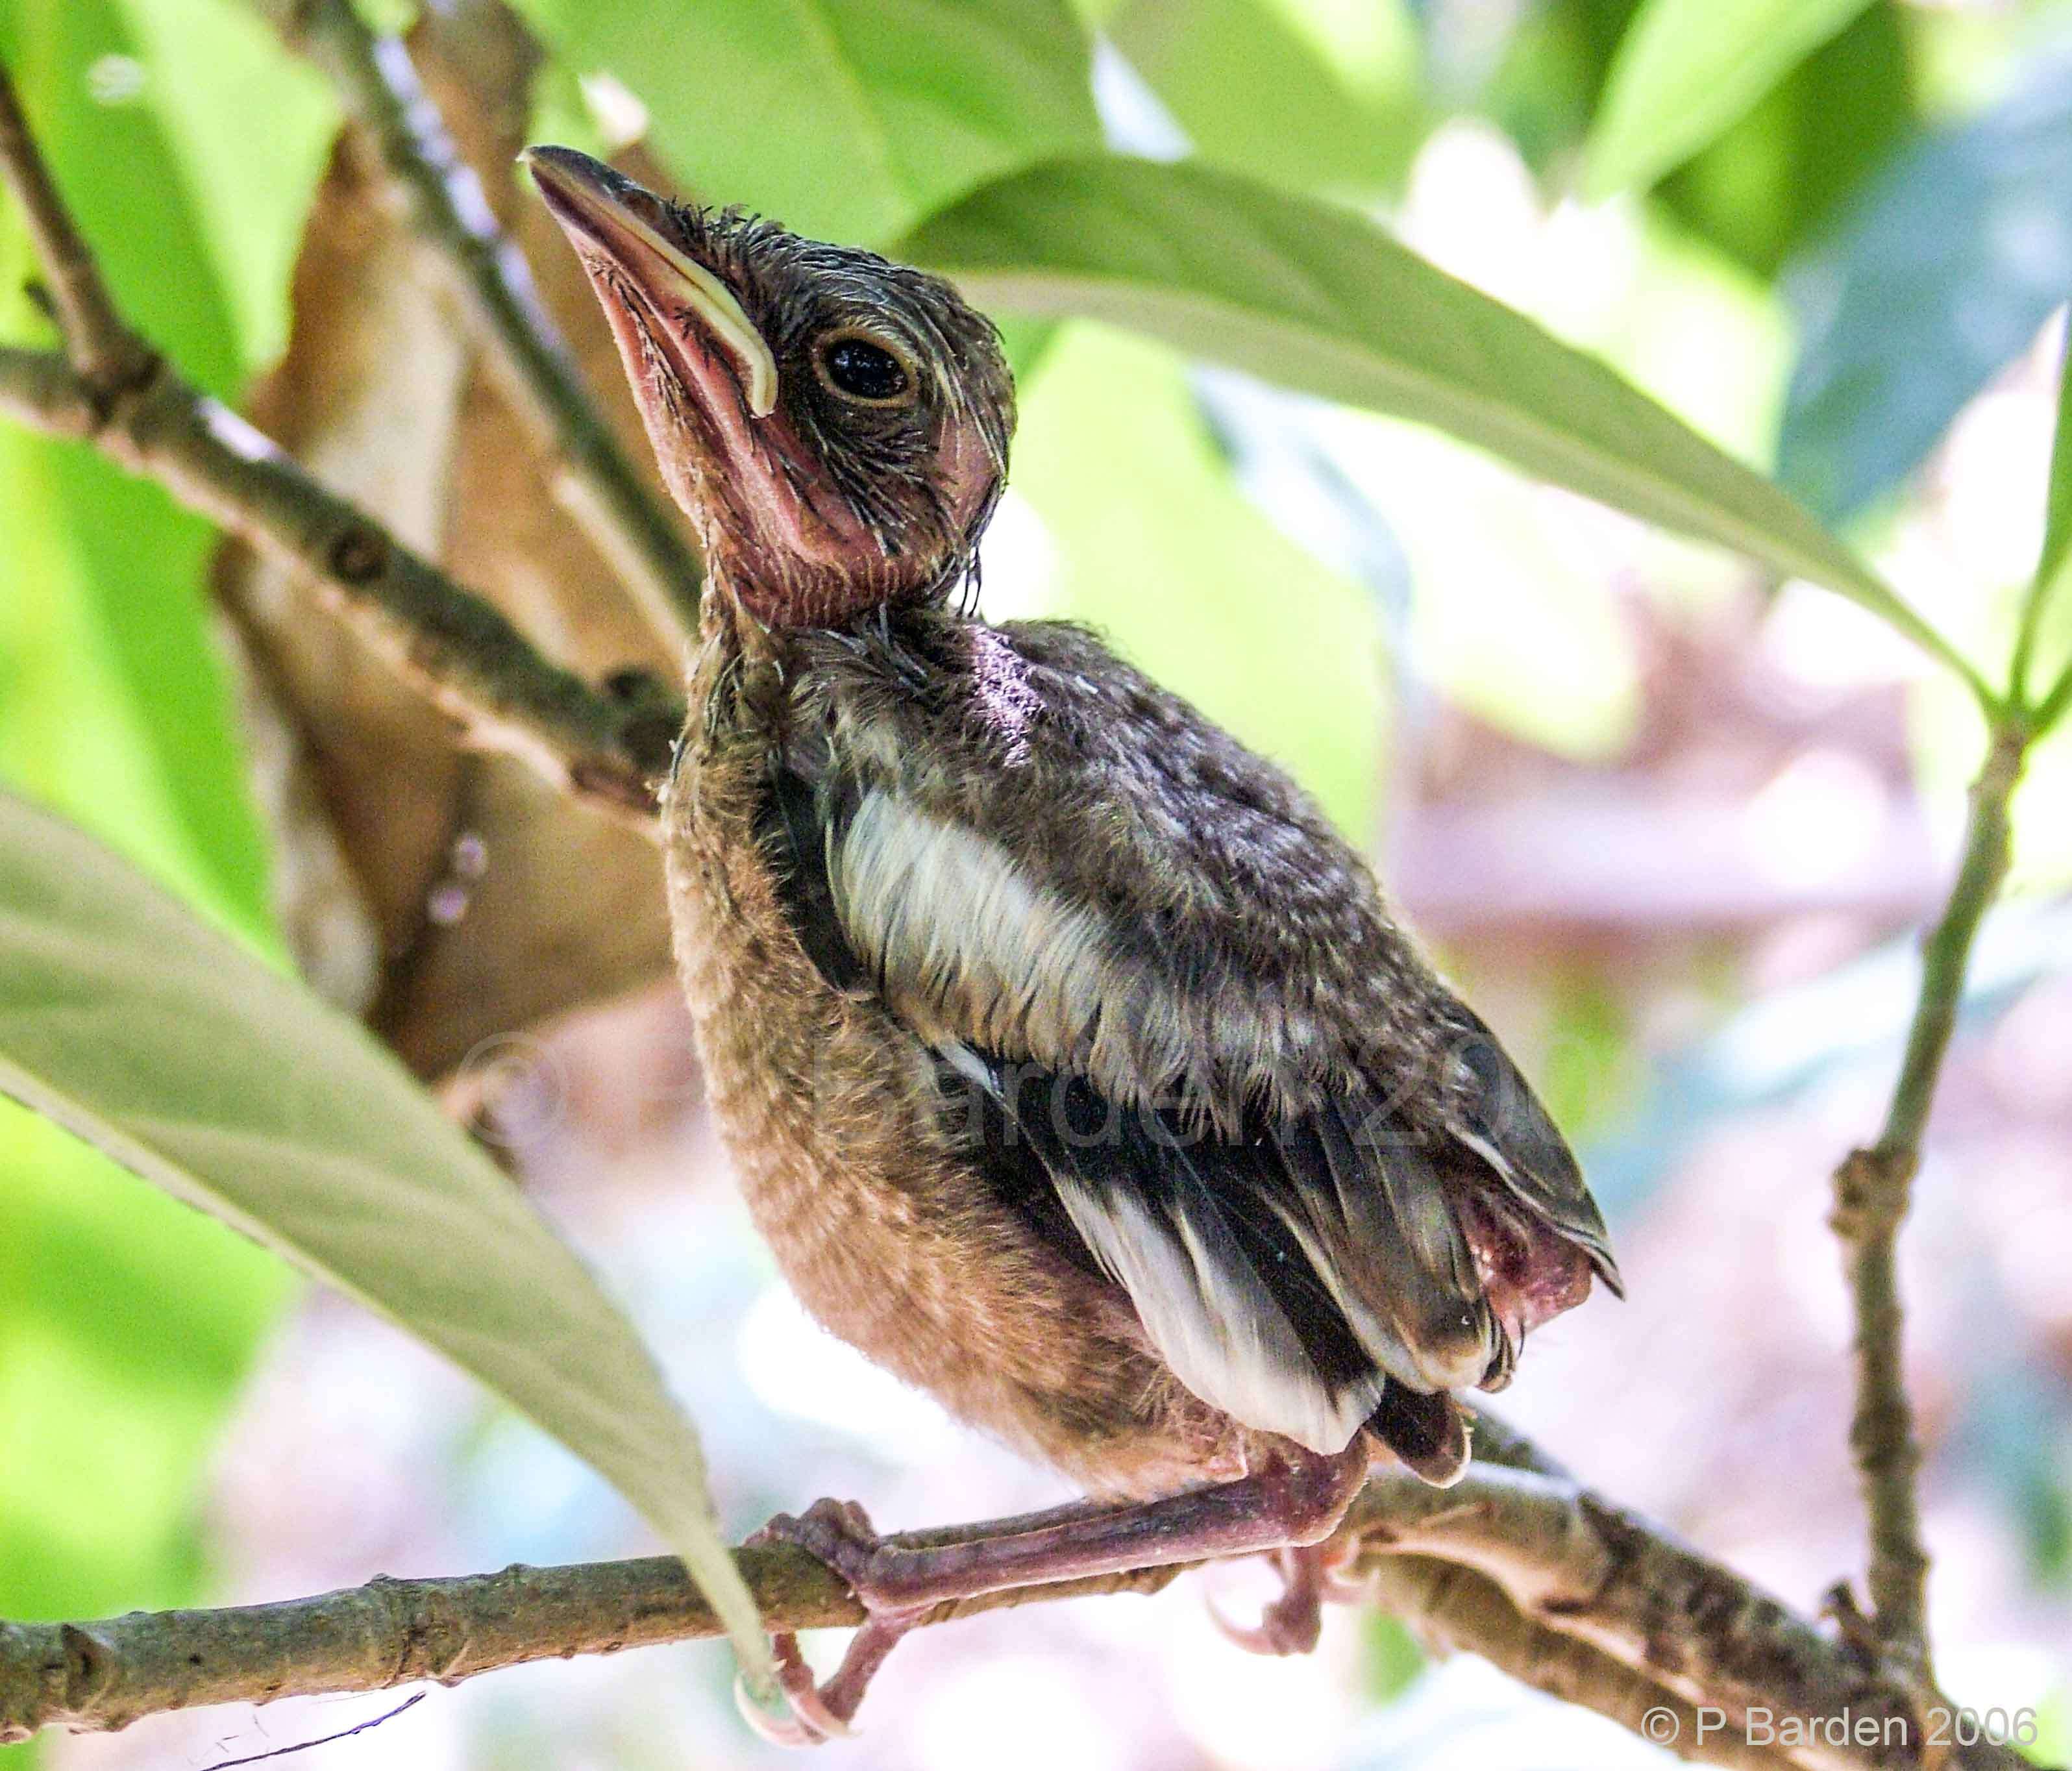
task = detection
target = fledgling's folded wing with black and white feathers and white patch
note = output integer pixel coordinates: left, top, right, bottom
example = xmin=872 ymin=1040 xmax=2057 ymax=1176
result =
xmin=763 ymin=762 xmax=1558 ymax=1477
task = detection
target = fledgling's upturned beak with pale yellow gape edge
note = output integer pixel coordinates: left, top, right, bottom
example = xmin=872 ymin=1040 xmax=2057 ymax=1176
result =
xmin=518 ymin=147 xmax=777 ymax=419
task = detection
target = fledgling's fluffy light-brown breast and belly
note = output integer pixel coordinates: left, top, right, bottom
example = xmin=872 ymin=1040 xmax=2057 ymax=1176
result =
xmin=663 ymin=661 xmax=1243 ymax=1493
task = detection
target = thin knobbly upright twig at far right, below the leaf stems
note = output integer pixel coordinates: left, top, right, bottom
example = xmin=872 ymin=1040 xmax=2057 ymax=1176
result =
xmin=1830 ymin=725 xmax=2029 ymax=1680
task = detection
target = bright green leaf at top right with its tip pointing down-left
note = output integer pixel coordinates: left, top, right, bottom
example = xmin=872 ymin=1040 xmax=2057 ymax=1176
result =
xmin=1583 ymin=0 xmax=1871 ymax=197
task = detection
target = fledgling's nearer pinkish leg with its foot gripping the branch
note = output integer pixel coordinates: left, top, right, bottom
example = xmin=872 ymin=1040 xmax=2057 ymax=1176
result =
xmin=737 ymin=1437 xmax=1370 ymax=1744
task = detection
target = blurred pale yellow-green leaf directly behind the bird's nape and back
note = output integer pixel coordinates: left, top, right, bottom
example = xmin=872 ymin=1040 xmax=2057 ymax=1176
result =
xmin=1007 ymin=325 xmax=1384 ymax=841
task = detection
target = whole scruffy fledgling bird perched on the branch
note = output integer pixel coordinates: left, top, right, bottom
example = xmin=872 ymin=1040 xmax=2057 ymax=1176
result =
xmin=524 ymin=147 xmax=1622 ymax=1742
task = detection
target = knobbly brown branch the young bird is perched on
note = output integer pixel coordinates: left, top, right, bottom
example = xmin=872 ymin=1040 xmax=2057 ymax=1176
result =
xmin=0 ymin=1442 xmax=2022 ymax=1771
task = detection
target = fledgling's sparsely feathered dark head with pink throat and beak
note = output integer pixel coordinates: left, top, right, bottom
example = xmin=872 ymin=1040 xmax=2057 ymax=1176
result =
xmin=524 ymin=147 xmax=1013 ymax=628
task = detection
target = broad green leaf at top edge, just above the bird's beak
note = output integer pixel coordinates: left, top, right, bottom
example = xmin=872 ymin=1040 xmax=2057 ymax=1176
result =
xmin=505 ymin=0 xmax=1100 ymax=240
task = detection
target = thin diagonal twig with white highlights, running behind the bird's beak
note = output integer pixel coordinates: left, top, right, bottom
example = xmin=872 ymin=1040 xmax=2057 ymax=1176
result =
xmin=245 ymin=0 xmax=702 ymax=640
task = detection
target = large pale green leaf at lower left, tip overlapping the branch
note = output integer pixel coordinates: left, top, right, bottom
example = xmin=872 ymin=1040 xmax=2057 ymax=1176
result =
xmin=0 ymin=795 xmax=771 ymax=1690
